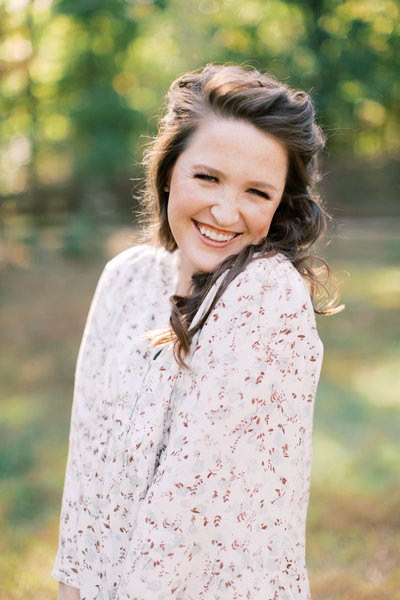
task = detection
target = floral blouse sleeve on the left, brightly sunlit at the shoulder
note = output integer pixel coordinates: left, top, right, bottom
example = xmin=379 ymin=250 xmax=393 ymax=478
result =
xmin=52 ymin=246 xmax=173 ymax=584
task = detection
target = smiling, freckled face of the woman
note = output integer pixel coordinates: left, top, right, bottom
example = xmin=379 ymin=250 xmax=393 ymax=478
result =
xmin=168 ymin=117 xmax=288 ymax=290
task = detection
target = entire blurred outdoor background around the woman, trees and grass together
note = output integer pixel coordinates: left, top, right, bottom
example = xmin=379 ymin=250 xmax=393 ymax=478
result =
xmin=0 ymin=0 xmax=400 ymax=600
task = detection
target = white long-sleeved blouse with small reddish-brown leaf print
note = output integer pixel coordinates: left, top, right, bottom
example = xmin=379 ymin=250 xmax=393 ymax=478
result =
xmin=52 ymin=246 xmax=322 ymax=600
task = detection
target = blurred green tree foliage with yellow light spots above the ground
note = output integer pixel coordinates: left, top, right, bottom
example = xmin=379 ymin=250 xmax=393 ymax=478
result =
xmin=0 ymin=0 xmax=400 ymax=218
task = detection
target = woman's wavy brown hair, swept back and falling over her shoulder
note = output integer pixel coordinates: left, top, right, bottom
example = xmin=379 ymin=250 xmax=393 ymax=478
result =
xmin=140 ymin=64 xmax=339 ymax=365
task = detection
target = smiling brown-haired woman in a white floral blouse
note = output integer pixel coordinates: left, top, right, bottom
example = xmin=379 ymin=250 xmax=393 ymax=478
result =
xmin=53 ymin=65 xmax=338 ymax=600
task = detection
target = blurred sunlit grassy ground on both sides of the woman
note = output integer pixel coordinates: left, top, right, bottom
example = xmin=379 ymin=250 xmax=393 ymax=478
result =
xmin=0 ymin=220 xmax=400 ymax=600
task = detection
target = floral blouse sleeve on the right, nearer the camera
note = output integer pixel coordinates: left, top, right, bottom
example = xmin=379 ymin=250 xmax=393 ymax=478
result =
xmin=115 ymin=259 xmax=322 ymax=600
